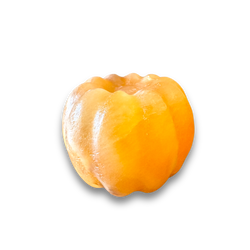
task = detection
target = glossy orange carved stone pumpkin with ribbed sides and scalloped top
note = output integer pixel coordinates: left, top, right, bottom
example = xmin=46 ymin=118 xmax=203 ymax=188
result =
xmin=62 ymin=71 xmax=195 ymax=197
